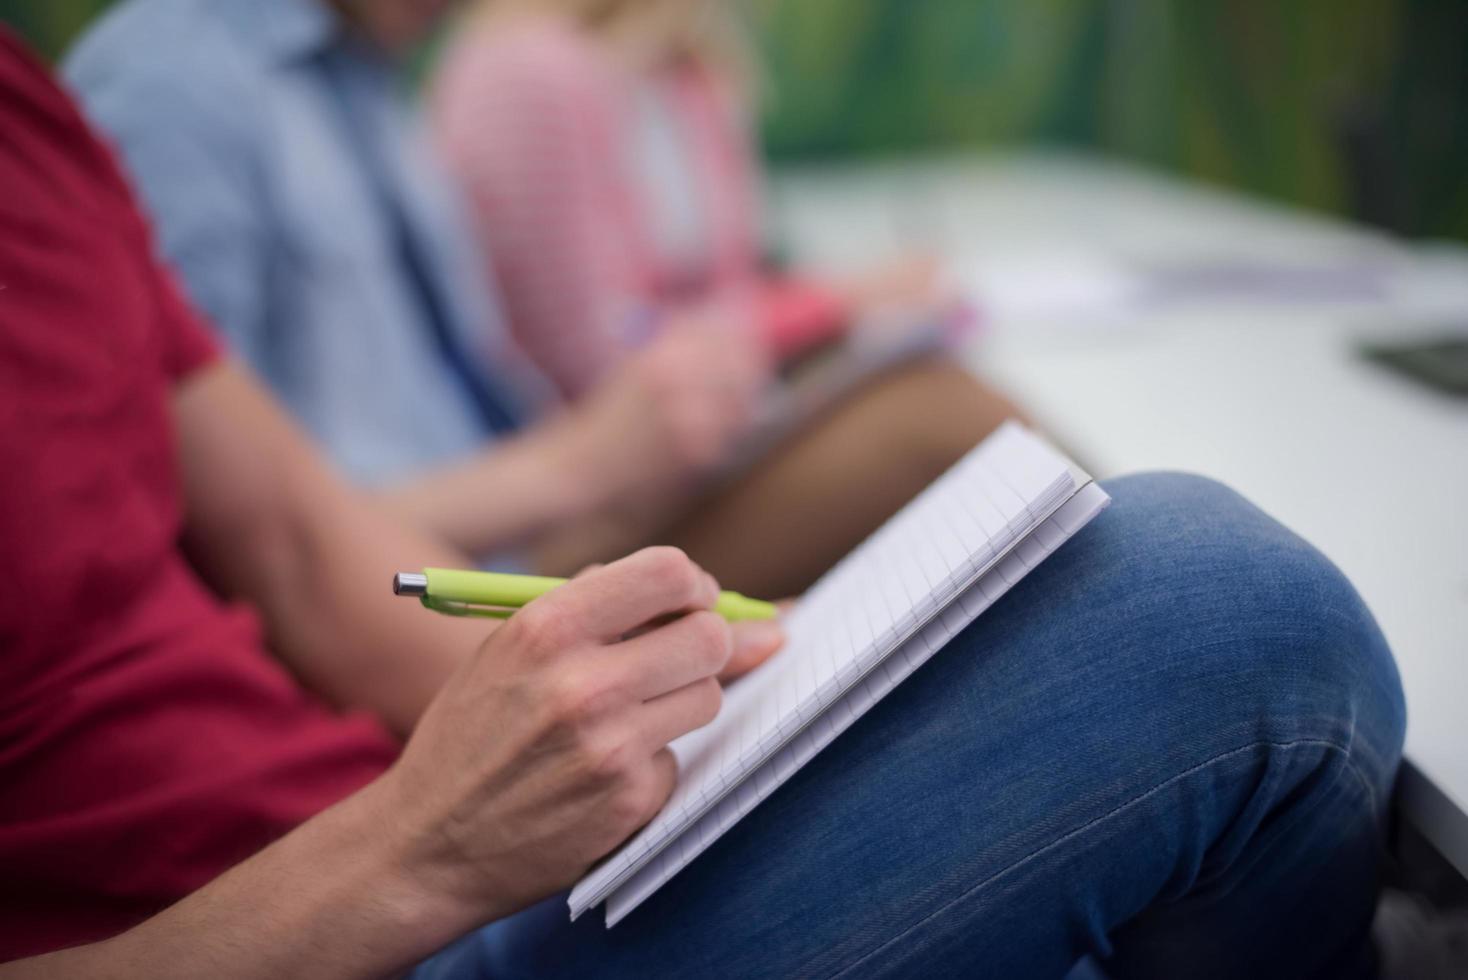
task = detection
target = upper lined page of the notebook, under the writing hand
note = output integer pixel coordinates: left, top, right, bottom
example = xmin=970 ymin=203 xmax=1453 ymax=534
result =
xmin=571 ymin=423 xmax=1075 ymax=915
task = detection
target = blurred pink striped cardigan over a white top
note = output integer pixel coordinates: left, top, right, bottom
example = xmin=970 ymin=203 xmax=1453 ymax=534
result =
xmin=432 ymin=18 xmax=847 ymax=398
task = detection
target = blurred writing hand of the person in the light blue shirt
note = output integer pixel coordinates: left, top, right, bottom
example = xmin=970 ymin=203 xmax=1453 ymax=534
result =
xmin=575 ymin=321 xmax=769 ymax=500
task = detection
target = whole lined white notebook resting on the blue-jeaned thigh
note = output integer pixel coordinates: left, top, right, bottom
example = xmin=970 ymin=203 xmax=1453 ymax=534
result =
xmin=568 ymin=423 xmax=1110 ymax=927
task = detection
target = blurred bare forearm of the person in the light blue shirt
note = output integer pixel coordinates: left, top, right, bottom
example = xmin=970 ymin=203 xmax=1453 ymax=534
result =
xmin=376 ymin=404 xmax=611 ymax=556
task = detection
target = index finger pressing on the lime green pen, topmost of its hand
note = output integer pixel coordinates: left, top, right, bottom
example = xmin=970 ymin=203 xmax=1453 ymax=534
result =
xmin=525 ymin=547 xmax=718 ymax=648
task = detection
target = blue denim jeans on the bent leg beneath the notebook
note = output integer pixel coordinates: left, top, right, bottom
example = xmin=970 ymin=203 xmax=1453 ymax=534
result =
xmin=415 ymin=475 xmax=1405 ymax=980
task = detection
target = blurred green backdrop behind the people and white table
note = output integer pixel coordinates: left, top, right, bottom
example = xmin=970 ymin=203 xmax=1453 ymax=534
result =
xmin=11 ymin=0 xmax=1468 ymax=239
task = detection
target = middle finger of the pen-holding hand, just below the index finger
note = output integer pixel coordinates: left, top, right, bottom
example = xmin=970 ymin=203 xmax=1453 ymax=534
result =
xmin=606 ymin=610 xmax=734 ymax=701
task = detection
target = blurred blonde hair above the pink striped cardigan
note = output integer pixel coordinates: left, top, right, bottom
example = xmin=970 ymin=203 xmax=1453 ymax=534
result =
xmin=480 ymin=0 xmax=759 ymax=95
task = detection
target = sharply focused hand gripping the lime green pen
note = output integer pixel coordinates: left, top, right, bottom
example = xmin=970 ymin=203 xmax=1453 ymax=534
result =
xmin=374 ymin=547 xmax=781 ymax=921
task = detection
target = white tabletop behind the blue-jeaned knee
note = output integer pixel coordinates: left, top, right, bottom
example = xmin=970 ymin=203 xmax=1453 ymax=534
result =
xmin=772 ymin=156 xmax=1468 ymax=874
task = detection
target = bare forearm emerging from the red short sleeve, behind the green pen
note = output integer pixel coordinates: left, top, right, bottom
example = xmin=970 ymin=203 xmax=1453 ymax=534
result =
xmin=175 ymin=365 xmax=493 ymax=732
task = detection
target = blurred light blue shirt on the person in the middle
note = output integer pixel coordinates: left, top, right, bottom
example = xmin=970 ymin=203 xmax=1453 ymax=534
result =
xmin=66 ymin=0 xmax=549 ymax=483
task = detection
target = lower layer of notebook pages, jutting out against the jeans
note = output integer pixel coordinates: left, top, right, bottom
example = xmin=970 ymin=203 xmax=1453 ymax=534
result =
xmin=606 ymin=483 xmax=1111 ymax=929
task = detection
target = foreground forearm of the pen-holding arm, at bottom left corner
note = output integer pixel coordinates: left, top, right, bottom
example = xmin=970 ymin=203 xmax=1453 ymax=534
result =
xmin=0 ymin=780 xmax=479 ymax=980
